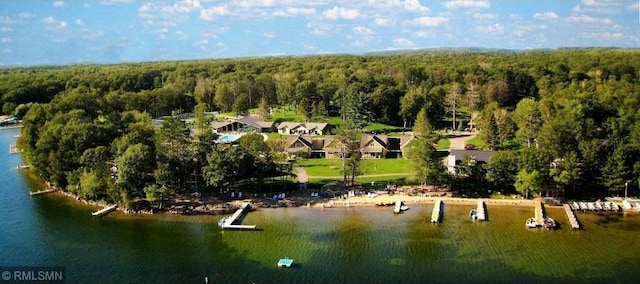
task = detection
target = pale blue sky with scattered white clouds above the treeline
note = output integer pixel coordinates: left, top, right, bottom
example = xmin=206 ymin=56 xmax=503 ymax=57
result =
xmin=0 ymin=0 xmax=640 ymax=66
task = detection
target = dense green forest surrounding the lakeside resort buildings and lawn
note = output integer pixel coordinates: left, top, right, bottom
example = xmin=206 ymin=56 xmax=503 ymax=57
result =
xmin=0 ymin=49 xmax=640 ymax=209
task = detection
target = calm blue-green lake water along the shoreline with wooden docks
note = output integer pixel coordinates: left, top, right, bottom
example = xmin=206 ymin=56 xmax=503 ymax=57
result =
xmin=0 ymin=127 xmax=640 ymax=283
